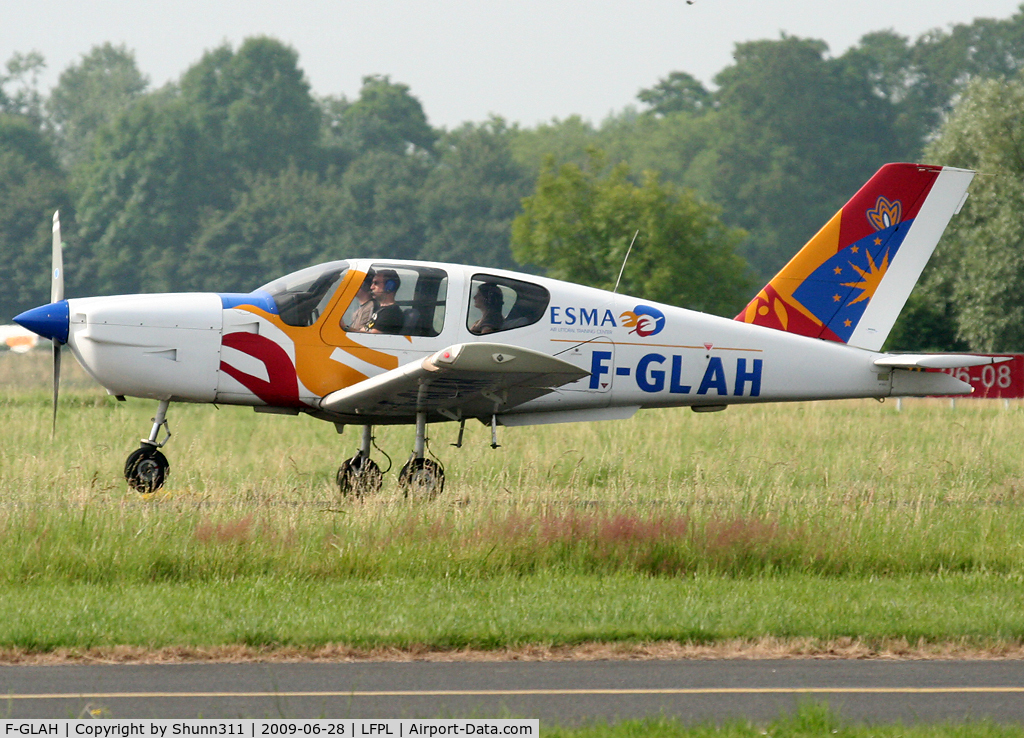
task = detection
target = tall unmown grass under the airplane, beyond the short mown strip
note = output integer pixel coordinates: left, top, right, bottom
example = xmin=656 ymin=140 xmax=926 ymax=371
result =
xmin=0 ymin=354 xmax=1024 ymax=584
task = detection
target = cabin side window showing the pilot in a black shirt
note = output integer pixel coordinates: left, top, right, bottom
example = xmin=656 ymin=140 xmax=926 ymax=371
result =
xmin=341 ymin=264 xmax=447 ymax=336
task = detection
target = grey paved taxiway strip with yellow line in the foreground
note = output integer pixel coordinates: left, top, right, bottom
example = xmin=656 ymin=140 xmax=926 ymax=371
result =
xmin=0 ymin=659 xmax=1024 ymax=725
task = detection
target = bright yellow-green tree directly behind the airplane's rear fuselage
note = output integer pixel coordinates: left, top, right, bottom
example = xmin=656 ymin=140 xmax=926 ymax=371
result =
xmin=512 ymin=150 xmax=750 ymax=315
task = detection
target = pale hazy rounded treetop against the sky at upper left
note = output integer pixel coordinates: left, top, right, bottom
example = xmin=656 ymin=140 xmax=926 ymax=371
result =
xmin=45 ymin=43 xmax=148 ymax=168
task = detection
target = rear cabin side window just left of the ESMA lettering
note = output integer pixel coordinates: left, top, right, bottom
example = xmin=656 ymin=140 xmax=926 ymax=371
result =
xmin=466 ymin=274 xmax=551 ymax=336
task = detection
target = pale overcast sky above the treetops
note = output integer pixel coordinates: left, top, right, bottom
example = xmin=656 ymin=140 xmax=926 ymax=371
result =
xmin=8 ymin=0 xmax=1020 ymax=128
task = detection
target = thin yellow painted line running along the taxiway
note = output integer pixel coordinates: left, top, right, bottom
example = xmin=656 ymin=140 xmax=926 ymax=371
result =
xmin=6 ymin=687 xmax=1024 ymax=701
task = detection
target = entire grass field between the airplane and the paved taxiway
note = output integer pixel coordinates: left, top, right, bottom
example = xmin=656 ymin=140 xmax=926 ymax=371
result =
xmin=0 ymin=353 xmax=1024 ymax=654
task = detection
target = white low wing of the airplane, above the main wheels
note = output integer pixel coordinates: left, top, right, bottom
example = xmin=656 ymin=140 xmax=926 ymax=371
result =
xmin=321 ymin=343 xmax=590 ymax=420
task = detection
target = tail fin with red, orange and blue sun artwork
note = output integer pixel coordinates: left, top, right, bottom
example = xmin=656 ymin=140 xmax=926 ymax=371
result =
xmin=736 ymin=164 xmax=974 ymax=351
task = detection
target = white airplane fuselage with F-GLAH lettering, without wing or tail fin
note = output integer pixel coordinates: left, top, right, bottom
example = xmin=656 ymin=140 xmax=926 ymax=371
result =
xmin=56 ymin=255 xmax=964 ymax=425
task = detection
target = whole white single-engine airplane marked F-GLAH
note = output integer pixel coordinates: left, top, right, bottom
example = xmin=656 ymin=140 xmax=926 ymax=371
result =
xmin=15 ymin=164 xmax=999 ymax=496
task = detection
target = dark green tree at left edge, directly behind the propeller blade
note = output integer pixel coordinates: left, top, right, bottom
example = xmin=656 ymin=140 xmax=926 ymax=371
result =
xmin=0 ymin=114 xmax=74 ymax=322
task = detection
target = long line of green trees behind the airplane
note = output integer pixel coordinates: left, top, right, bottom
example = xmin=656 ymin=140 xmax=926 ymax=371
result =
xmin=6 ymin=6 xmax=1024 ymax=350
